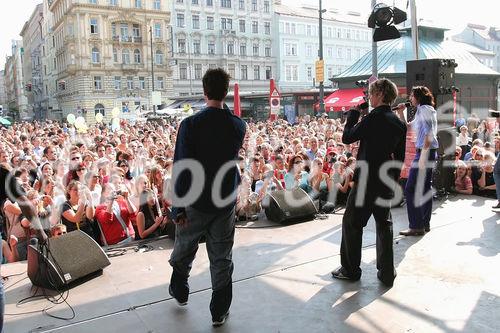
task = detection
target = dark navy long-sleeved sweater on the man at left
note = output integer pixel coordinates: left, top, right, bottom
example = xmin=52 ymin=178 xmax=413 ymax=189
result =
xmin=172 ymin=107 xmax=246 ymax=218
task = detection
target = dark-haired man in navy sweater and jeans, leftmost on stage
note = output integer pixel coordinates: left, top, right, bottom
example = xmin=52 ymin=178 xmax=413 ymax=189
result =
xmin=169 ymin=68 xmax=246 ymax=326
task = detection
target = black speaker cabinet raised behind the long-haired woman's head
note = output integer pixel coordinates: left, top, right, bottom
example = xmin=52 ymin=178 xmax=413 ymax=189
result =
xmin=406 ymin=59 xmax=455 ymax=128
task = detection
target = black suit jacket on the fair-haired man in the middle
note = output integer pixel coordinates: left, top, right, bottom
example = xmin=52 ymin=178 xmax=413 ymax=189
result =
xmin=342 ymin=105 xmax=406 ymax=195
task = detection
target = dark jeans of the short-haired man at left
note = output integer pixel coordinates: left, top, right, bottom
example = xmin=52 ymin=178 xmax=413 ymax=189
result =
xmin=169 ymin=207 xmax=235 ymax=320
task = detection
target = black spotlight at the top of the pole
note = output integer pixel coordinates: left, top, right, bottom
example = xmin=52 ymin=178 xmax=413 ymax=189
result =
xmin=368 ymin=3 xmax=407 ymax=42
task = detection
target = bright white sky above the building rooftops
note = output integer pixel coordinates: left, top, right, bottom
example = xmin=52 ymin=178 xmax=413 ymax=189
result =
xmin=0 ymin=0 xmax=500 ymax=69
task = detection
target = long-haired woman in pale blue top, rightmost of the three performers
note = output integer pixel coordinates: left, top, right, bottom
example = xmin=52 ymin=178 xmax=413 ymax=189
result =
xmin=397 ymin=86 xmax=439 ymax=236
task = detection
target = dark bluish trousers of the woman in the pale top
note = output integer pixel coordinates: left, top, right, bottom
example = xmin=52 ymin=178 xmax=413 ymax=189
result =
xmin=405 ymin=149 xmax=436 ymax=229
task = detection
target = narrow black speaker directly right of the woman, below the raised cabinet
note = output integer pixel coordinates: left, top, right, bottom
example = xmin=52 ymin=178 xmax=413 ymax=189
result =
xmin=432 ymin=127 xmax=456 ymax=192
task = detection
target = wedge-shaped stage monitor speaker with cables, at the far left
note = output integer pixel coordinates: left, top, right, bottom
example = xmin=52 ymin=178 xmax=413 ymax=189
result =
xmin=28 ymin=230 xmax=110 ymax=290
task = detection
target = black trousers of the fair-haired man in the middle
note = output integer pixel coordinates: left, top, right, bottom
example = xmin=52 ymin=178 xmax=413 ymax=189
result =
xmin=340 ymin=184 xmax=394 ymax=279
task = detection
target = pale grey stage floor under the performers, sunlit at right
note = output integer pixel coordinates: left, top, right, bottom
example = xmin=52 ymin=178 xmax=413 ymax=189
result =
xmin=2 ymin=196 xmax=500 ymax=333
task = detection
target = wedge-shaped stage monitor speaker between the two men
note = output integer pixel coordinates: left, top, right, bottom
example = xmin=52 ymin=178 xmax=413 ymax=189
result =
xmin=263 ymin=188 xmax=318 ymax=224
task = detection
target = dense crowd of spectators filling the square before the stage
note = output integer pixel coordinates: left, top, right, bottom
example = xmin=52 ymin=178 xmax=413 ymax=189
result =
xmin=0 ymin=107 xmax=500 ymax=262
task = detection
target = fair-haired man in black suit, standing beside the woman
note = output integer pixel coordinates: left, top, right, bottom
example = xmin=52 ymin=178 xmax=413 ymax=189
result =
xmin=332 ymin=79 xmax=406 ymax=286
